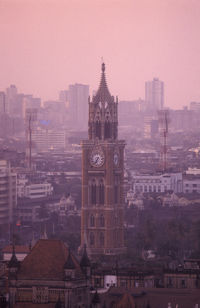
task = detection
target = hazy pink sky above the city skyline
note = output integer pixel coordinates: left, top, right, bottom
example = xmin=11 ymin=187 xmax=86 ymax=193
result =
xmin=0 ymin=0 xmax=200 ymax=108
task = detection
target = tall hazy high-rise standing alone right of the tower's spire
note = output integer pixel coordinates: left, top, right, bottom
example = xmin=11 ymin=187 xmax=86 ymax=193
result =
xmin=145 ymin=78 xmax=164 ymax=111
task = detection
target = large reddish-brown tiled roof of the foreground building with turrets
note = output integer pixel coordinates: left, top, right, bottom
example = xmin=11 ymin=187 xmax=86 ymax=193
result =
xmin=17 ymin=240 xmax=82 ymax=280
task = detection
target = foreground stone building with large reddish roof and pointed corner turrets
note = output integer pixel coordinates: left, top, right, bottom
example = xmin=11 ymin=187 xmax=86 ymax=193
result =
xmin=2 ymin=240 xmax=90 ymax=308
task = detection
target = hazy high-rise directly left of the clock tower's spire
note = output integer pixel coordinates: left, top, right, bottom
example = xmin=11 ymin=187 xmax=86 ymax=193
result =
xmin=68 ymin=83 xmax=89 ymax=129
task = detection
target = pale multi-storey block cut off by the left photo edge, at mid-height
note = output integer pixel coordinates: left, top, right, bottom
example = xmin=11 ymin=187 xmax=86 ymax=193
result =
xmin=0 ymin=160 xmax=17 ymax=225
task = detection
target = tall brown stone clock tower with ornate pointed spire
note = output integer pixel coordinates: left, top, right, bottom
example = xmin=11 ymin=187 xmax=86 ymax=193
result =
xmin=81 ymin=63 xmax=125 ymax=257
